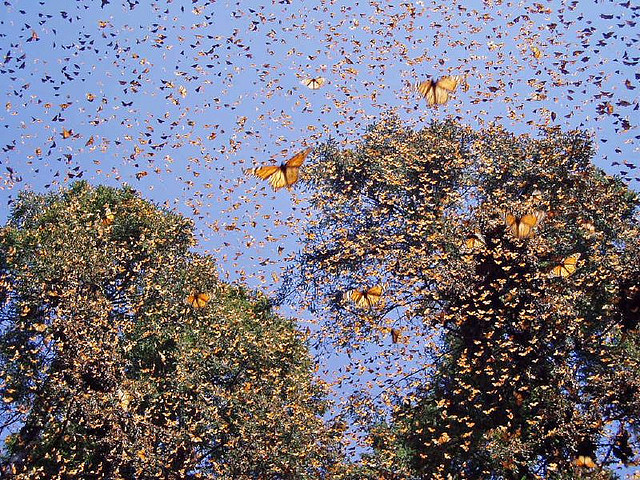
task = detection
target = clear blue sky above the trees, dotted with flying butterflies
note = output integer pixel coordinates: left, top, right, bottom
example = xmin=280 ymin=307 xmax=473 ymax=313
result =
xmin=0 ymin=0 xmax=640 ymax=472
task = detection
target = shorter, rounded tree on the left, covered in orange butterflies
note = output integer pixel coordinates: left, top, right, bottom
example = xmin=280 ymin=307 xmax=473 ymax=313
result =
xmin=0 ymin=182 xmax=339 ymax=479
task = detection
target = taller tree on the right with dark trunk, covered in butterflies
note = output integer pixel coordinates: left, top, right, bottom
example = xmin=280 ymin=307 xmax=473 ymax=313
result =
xmin=284 ymin=118 xmax=640 ymax=480
